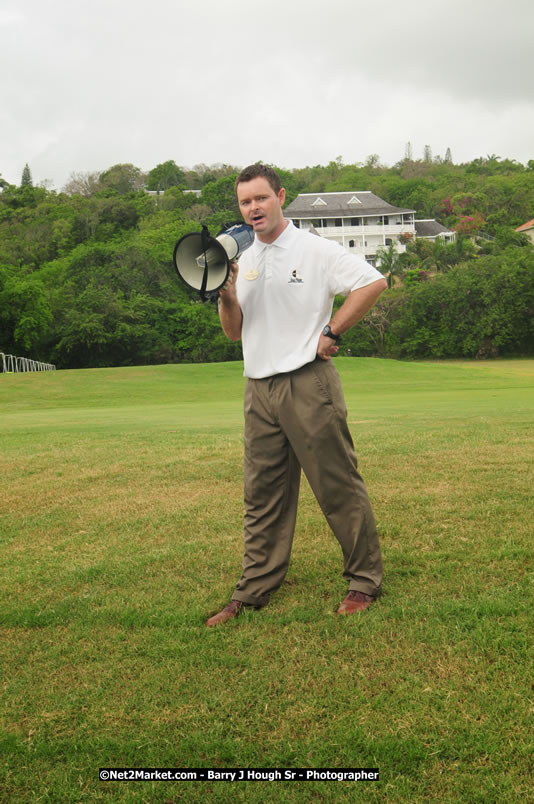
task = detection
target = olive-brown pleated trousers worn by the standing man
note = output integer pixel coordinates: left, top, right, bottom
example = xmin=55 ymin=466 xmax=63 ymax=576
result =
xmin=233 ymin=358 xmax=382 ymax=606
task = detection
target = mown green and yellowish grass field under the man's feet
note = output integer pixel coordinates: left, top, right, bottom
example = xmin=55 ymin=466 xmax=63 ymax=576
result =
xmin=0 ymin=358 xmax=534 ymax=803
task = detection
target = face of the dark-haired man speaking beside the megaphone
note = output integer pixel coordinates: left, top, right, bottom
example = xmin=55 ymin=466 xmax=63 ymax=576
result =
xmin=237 ymin=176 xmax=286 ymax=243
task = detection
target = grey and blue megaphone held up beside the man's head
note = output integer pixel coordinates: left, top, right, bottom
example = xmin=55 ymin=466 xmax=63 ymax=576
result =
xmin=173 ymin=223 xmax=254 ymax=301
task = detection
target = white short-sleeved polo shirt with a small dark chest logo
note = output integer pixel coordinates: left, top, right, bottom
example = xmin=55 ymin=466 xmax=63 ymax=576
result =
xmin=236 ymin=221 xmax=383 ymax=379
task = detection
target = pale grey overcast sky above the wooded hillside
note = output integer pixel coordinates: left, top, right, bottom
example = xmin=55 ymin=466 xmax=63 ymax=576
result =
xmin=0 ymin=0 xmax=534 ymax=189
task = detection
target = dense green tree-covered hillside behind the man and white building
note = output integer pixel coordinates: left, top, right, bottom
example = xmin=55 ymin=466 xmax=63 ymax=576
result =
xmin=0 ymin=154 xmax=534 ymax=368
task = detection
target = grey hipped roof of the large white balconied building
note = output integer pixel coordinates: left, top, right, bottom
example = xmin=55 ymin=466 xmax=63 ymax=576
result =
xmin=284 ymin=190 xmax=415 ymax=218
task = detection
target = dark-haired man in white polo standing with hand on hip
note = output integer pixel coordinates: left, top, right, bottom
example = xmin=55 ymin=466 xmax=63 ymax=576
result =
xmin=206 ymin=164 xmax=387 ymax=627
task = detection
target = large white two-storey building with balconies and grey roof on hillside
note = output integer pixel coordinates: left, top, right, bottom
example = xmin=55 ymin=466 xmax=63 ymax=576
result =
xmin=284 ymin=190 xmax=416 ymax=265
